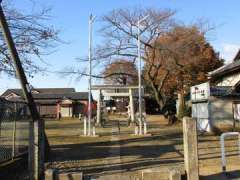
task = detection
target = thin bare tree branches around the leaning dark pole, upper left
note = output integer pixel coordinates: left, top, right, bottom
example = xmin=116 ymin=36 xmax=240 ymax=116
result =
xmin=0 ymin=0 xmax=60 ymax=76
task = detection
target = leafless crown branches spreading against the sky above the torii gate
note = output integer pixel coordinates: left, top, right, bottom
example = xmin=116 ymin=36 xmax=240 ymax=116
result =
xmin=64 ymin=9 xmax=175 ymax=78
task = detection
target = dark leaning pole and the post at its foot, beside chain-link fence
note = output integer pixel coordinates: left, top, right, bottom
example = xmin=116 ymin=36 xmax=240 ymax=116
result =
xmin=0 ymin=1 xmax=47 ymax=180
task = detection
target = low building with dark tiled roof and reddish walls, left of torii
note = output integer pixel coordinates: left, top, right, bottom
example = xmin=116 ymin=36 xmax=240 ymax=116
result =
xmin=1 ymin=88 xmax=93 ymax=118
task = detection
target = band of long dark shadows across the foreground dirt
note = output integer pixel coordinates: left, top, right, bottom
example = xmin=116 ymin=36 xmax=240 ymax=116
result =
xmin=46 ymin=128 xmax=183 ymax=177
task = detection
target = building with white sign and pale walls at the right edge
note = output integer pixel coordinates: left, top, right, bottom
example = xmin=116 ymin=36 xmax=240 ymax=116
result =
xmin=191 ymin=51 xmax=240 ymax=131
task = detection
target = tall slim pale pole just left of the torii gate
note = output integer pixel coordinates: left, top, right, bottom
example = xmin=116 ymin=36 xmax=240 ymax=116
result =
xmin=88 ymin=14 xmax=95 ymax=136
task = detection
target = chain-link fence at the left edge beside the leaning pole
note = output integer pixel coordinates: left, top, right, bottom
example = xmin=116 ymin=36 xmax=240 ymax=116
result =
xmin=0 ymin=99 xmax=30 ymax=163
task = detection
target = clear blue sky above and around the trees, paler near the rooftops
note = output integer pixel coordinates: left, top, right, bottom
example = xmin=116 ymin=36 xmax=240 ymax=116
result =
xmin=0 ymin=0 xmax=240 ymax=93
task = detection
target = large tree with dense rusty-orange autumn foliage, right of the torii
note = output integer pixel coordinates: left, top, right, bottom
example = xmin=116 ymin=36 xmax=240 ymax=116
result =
xmin=144 ymin=26 xmax=223 ymax=107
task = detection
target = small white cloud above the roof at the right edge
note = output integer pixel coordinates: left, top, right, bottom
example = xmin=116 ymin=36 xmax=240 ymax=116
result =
xmin=220 ymin=43 xmax=240 ymax=62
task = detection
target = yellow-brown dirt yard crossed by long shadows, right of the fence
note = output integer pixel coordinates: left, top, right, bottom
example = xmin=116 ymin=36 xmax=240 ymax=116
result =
xmin=46 ymin=117 xmax=240 ymax=180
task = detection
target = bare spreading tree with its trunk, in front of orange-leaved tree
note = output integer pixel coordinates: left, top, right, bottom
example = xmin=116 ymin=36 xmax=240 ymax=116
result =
xmin=90 ymin=9 xmax=176 ymax=108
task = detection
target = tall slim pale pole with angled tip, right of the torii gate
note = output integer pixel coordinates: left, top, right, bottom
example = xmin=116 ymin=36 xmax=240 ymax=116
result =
xmin=137 ymin=15 xmax=149 ymax=135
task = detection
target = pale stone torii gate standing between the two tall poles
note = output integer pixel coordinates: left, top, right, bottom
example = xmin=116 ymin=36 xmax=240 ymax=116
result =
xmin=92 ymin=85 xmax=144 ymax=124
